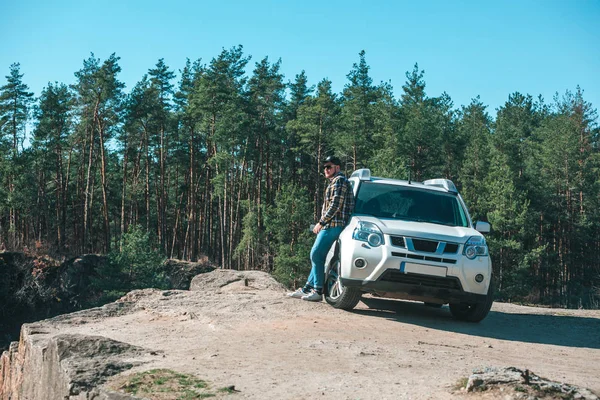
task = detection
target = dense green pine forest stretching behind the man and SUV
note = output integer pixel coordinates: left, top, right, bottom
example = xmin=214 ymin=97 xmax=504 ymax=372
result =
xmin=0 ymin=46 xmax=600 ymax=308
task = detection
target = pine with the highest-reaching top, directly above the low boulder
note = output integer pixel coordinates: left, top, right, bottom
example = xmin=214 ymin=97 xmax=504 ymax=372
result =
xmin=190 ymin=46 xmax=251 ymax=267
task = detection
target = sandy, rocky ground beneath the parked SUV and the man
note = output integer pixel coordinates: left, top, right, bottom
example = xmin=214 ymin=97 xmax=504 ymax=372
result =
xmin=0 ymin=270 xmax=600 ymax=399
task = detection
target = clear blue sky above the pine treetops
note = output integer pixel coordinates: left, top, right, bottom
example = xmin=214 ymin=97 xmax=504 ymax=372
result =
xmin=0 ymin=0 xmax=600 ymax=117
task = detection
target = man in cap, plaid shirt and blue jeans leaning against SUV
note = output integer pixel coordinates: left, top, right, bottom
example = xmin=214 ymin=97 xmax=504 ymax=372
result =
xmin=288 ymin=156 xmax=354 ymax=301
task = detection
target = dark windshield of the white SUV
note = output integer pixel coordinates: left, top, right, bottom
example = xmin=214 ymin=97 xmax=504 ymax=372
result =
xmin=354 ymin=182 xmax=469 ymax=227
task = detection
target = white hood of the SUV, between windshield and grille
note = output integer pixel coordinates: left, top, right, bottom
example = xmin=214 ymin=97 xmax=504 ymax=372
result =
xmin=351 ymin=215 xmax=483 ymax=243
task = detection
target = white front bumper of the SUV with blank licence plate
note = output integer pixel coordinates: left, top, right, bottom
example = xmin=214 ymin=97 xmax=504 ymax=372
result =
xmin=340 ymin=230 xmax=492 ymax=304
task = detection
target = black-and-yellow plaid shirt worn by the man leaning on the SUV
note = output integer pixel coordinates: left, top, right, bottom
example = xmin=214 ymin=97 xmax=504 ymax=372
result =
xmin=319 ymin=172 xmax=354 ymax=228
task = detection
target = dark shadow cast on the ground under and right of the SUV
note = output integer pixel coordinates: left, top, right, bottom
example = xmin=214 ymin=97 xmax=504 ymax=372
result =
xmin=353 ymin=297 xmax=600 ymax=349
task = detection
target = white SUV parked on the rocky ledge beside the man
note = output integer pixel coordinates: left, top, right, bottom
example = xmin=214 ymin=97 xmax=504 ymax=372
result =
xmin=325 ymin=169 xmax=493 ymax=322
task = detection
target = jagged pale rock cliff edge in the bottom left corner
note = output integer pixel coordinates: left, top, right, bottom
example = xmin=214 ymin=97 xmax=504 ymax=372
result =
xmin=0 ymin=303 xmax=149 ymax=400
